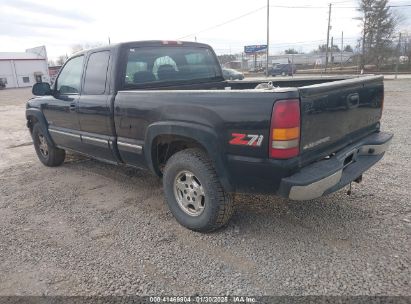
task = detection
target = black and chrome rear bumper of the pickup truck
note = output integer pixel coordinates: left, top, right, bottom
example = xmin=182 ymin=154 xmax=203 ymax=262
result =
xmin=278 ymin=132 xmax=393 ymax=200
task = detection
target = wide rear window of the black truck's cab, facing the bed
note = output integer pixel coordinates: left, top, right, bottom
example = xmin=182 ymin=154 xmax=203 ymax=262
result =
xmin=125 ymin=46 xmax=221 ymax=87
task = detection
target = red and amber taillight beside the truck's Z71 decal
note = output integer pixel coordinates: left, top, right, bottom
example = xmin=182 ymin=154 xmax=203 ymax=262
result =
xmin=269 ymin=99 xmax=300 ymax=159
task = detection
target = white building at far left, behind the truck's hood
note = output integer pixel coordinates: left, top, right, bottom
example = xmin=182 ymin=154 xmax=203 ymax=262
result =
xmin=0 ymin=46 xmax=50 ymax=88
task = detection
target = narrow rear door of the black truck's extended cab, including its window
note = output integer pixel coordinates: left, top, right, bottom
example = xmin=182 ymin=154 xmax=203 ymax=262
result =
xmin=78 ymin=51 xmax=116 ymax=161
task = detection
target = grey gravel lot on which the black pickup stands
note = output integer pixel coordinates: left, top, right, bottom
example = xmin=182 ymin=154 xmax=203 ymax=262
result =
xmin=0 ymin=79 xmax=411 ymax=296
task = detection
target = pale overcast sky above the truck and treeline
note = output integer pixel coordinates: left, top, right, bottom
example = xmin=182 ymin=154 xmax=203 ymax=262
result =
xmin=0 ymin=0 xmax=408 ymax=58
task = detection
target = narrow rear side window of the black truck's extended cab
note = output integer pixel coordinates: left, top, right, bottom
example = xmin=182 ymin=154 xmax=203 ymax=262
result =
xmin=83 ymin=51 xmax=110 ymax=95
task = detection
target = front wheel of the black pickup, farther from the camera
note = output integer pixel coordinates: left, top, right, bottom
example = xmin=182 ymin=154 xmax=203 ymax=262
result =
xmin=31 ymin=123 xmax=66 ymax=167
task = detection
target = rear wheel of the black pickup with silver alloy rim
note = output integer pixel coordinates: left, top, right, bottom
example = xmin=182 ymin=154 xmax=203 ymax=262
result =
xmin=163 ymin=149 xmax=234 ymax=232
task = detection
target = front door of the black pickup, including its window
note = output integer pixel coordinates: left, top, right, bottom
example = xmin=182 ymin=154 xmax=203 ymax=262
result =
xmin=43 ymin=55 xmax=84 ymax=150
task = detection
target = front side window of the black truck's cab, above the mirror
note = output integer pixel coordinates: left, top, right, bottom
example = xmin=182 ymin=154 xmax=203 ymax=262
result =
xmin=56 ymin=56 xmax=84 ymax=94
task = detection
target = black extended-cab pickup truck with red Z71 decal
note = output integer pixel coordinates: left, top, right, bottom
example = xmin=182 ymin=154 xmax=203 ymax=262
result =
xmin=26 ymin=41 xmax=392 ymax=231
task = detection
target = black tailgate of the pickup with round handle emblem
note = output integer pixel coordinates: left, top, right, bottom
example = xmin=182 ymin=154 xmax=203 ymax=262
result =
xmin=299 ymin=76 xmax=384 ymax=161
